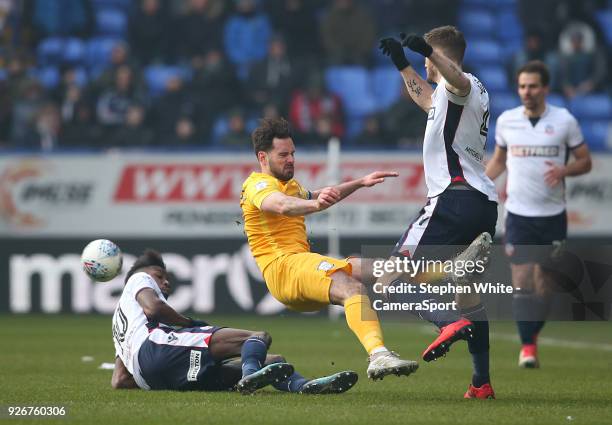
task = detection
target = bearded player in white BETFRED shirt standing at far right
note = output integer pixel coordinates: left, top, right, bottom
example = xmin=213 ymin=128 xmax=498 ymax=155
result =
xmin=487 ymin=61 xmax=591 ymax=368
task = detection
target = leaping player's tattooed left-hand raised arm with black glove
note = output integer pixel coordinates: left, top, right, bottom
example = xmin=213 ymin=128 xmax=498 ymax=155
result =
xmin=378 ymin=37 xmax=433 ymax=112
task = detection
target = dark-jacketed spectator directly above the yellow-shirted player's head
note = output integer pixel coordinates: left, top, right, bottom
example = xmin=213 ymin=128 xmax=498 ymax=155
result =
xmin=248 ymin=36 xmax=293 ymax=109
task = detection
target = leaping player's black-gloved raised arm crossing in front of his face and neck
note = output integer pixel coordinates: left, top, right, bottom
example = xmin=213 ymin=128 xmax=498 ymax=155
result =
xmin=400 ymin=33 xmax=471 ymax=96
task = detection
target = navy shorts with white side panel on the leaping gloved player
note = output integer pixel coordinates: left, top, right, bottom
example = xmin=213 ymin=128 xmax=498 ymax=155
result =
xmin=393 ymin=189 xmax=497 ymax=261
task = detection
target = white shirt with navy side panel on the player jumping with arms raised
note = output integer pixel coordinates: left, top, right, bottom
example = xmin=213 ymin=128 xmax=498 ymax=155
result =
xmin=423 ymin=73 xmax=497 ymax=201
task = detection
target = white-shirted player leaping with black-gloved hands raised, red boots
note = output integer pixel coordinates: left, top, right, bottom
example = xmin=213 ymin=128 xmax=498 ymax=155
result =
xmin=380 ymin=26 xmax=497 ymax=398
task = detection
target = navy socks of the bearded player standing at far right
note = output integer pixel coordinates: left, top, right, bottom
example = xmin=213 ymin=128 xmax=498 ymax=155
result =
xmin=512 ymin=293 xmax=550 ymax=344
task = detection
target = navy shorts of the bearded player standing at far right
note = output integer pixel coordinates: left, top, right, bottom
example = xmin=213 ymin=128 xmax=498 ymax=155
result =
xmin=504 ymin=211 xmax=567 ymax=264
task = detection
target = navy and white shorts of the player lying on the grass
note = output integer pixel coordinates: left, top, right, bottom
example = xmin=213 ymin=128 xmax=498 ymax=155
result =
xmin=138 ymin=326 xmax=233 ymax=391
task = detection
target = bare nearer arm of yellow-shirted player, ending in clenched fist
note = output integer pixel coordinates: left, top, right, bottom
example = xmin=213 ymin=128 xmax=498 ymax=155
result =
xmin=261 ymin=188 xmax=340 ymax=216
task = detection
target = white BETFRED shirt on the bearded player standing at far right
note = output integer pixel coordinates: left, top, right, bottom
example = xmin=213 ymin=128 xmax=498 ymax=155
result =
xmin=495 ymin=104 xmax=584 ymax=217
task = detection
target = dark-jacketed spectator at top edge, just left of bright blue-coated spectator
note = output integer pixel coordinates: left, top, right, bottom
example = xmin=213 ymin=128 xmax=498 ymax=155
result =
xmin=173 ymin=0 xmax=225 ymax=64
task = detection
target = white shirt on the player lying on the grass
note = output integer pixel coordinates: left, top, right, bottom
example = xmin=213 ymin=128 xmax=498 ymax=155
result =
xmin=113 ymin=272 xmax=166 ymax=390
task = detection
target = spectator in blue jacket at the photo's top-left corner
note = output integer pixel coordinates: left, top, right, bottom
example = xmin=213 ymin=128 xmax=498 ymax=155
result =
xmin=20 ymin=0 xmax=95 ymax=45
